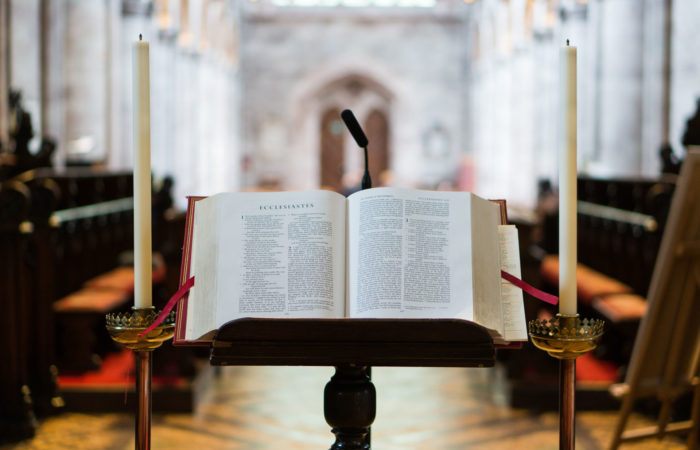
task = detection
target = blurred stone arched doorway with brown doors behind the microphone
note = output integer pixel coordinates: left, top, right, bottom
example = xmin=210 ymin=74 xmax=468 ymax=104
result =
xmin=285 ymin=58 xmax=420 ymax=191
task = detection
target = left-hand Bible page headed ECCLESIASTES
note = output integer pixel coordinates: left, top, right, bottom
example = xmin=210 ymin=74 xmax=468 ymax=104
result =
xmin=194 ymin=191 xmax=346 ymax=338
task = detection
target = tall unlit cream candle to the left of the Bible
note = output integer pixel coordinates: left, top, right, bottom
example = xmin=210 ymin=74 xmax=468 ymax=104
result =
xmin=132 ymin=35 xmax=152 ymax=308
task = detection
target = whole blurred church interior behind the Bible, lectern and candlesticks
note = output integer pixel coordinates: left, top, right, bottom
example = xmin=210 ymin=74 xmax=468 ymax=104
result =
xmin=0 ymin=0 xmax=700 ymax=449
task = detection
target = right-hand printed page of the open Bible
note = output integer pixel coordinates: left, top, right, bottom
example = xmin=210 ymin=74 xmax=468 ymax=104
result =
xmin=348 ymin=188 xmax=473 ymax=320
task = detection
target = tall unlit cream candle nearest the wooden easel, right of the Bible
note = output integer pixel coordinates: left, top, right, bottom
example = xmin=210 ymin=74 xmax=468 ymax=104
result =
xmin=559 ymin=39 xmax=577 ymax=314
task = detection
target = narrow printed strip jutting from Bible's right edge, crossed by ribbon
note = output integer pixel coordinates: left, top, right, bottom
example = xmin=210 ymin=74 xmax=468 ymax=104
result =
xmin=498 ymin=225 xmax=527 ymax=341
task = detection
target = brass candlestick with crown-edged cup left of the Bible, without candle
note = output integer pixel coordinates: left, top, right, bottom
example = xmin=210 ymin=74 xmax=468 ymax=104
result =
xmin=105 ymin=306 xmax=175 ymax=450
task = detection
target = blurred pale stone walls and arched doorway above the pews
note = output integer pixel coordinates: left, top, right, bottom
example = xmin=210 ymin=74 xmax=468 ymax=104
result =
xmin=0 ymin=0 xmax=700 ymax=208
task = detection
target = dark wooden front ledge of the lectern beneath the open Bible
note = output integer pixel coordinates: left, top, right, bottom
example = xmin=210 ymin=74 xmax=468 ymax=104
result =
xmin=210 ymin=318 xmax=495 ymax=367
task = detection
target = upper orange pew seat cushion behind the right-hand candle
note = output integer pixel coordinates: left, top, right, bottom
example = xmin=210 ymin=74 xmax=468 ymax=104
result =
xmin=540 ymin=255 xmax=632 ymax=305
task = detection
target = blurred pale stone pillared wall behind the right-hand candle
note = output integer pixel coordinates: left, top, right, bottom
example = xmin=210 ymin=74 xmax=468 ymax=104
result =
xmin=466 ymin=0 xmax=700 ymax=206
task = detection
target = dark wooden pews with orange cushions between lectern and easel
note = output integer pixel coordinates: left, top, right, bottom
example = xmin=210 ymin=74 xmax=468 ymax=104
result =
xmin=506 ymin=176 xmax=675 ymax=410
